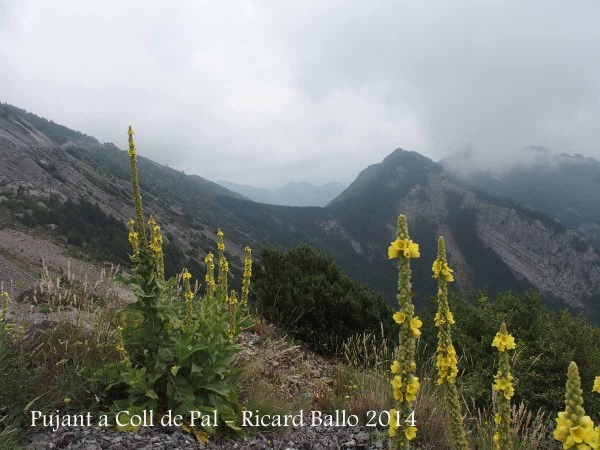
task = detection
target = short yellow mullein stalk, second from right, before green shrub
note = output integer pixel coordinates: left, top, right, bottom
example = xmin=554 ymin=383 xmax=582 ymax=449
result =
xmin=492 ymin=323 xmax=517 ymax=450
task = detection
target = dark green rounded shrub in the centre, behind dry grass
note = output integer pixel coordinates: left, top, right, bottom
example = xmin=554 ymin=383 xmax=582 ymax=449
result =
xmin=253 ymin=245 xmax=392 ymax=353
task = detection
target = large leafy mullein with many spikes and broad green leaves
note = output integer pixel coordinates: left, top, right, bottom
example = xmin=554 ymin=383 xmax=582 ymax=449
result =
xmin=102 ymin=127 xmax=244 ymax=441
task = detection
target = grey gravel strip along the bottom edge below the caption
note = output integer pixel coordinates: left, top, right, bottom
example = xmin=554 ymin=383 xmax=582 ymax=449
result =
xmin=27 ymin=427 xmax=384 ymax=450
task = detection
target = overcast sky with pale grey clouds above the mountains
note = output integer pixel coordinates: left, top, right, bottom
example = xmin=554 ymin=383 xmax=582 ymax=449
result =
xmin=0 ymin=0 xmax=600 ymax=187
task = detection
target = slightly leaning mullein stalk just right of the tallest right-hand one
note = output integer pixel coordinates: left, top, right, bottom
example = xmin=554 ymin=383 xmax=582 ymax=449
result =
xmin=432 ymin=236 xmax=469 ymax=450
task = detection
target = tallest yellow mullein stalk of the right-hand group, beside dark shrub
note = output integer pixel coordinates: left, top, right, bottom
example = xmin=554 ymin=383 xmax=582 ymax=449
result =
xmin=388 ymin=215 xmax=423 ymax=449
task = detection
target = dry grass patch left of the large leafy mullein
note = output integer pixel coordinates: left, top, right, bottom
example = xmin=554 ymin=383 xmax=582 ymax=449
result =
xmin=0 ymin=270 xmax=122 ymax=447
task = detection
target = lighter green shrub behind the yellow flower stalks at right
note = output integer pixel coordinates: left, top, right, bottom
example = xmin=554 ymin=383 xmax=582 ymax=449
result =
xmin=420 ymin=291 xmax=600 ymax=415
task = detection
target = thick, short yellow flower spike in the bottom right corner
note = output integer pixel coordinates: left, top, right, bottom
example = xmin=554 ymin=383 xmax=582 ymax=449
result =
xmin=554 ymin=361 xmax=600 ymax=450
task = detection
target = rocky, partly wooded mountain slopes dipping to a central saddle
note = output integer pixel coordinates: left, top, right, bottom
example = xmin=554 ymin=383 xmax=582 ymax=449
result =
xmin=0 ymin=105 xmax=600 ymax=316
